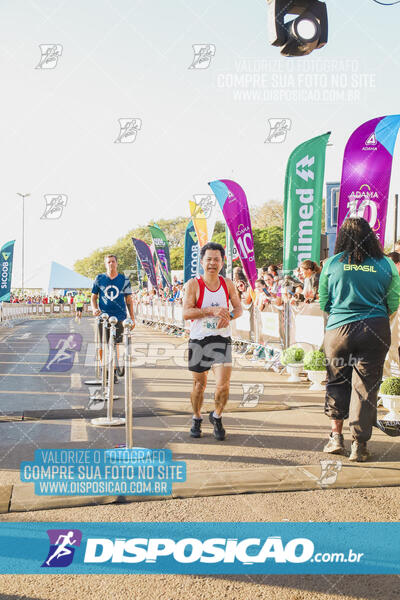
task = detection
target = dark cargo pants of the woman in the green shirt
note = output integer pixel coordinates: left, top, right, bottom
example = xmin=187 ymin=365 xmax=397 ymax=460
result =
xmin=324 ymin=317 xmax=390 ymax=442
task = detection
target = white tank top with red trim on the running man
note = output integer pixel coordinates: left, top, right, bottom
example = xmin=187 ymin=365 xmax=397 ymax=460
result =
xmin=190 ymin=275 xmax=231 ymax=340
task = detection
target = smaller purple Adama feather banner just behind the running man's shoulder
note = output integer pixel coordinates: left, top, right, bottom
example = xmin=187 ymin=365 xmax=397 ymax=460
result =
xmin=208 ymin=179 xmax=257 ymax=290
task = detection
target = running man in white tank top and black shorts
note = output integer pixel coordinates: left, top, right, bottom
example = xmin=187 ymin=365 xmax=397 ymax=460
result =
xmin=183 ymin=242 xmax=242 ymax=441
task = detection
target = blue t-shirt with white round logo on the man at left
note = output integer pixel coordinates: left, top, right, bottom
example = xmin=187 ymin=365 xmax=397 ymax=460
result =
xmin=92 ymin=273 xmax=132 ymax=321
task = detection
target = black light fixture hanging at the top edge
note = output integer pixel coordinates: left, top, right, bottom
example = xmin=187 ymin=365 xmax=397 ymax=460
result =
xmin=267 ymin=0 xmax=328 ymax=56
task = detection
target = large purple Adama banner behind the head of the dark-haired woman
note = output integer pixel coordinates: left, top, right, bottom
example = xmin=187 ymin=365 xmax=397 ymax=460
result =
xmin=338 ymin=115 xmax=400 ymax=246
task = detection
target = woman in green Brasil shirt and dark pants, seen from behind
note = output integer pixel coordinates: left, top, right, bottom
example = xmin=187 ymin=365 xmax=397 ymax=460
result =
xmin=318 ymin=218 xmax=400 ymax=462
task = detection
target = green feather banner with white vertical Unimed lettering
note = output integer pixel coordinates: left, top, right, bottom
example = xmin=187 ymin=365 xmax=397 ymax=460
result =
xmin=283 ymin=131 xmax=331 ymax=274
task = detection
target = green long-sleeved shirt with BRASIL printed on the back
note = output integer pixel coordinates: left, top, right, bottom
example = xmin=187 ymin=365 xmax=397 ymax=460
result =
xmin=318 ymin=252 xmax=400 ymax=329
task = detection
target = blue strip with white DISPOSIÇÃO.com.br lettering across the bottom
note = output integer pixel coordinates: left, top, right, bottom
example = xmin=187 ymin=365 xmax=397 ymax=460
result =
xmin=0 ymin=522 xmax=400 ymax=575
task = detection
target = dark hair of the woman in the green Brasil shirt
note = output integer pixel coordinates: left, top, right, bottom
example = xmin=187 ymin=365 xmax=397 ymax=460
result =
xmin=335 ymin=217 xmax=384 ymax=265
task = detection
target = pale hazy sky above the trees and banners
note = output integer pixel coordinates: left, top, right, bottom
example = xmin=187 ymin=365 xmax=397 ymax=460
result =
xmin=0 ymin=0 xmax=400 ymax=286
